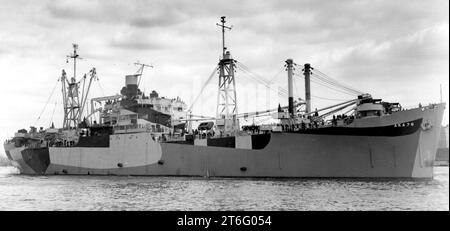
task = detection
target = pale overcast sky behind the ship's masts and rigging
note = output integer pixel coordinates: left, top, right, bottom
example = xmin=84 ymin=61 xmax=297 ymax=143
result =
xmin=0 ymin=0 xmax=449 ymax=153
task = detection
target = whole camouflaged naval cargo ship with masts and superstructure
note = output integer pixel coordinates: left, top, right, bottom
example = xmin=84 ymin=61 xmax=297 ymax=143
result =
xmin=4 ymin=17 xmax=445 ymax=179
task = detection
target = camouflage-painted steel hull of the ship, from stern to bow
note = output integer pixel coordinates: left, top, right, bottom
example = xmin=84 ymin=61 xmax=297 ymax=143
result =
xmin=5 ymin=104 xmax=444 ymax=178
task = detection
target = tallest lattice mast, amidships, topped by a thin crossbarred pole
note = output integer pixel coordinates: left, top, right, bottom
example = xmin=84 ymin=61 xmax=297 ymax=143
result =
xmin=216 ymin=16 xmax=239 ymax=135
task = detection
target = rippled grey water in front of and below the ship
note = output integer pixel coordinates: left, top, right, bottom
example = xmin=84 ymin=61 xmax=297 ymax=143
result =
xmin=0 ymin=167 xmax=449 ymax=211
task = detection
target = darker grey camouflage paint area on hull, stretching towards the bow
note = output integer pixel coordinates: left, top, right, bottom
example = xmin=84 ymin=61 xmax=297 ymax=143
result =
xmin=42 ymin=132 xmax=420 ymax=177
